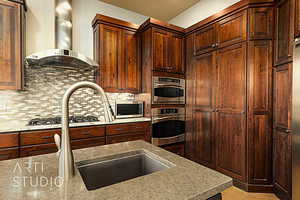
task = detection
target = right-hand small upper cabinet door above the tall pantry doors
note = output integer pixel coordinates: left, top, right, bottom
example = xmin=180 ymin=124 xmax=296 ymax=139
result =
xmin=217 ymin=11 xmax=247 ymax=47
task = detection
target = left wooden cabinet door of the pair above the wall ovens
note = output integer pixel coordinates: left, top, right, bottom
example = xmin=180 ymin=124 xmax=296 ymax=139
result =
xmin=153 ymin=29 xmax=170 ymax=71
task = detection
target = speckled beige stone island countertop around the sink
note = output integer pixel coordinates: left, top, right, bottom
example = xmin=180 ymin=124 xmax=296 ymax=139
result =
xmin=0 ymin=141 xmax=232 ymax=200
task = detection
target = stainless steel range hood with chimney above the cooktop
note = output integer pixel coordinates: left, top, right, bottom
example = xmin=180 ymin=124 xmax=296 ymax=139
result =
xmin=26 ymin=0 xmax=98 ymax=69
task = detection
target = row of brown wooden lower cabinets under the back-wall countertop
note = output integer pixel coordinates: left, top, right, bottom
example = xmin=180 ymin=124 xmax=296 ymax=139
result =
xmin=17 ymin=122 xmax=150 ymax=160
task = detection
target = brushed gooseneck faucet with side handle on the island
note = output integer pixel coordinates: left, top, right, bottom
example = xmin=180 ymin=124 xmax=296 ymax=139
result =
xmin=54 ymin=81 xmax=114 ymax=181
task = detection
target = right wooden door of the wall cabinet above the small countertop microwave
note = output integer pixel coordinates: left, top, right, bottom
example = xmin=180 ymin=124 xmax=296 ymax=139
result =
xmin=119 ymin=30 xmax=141 ymax=93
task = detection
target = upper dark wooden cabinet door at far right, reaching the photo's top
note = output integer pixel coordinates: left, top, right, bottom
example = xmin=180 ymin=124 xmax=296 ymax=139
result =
xmin=274 ymin=0 xmax=294 ymax=65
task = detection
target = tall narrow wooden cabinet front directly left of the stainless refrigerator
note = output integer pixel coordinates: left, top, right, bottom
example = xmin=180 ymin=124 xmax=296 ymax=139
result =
xmin=273 ymin=63 xmax=292 ymax=199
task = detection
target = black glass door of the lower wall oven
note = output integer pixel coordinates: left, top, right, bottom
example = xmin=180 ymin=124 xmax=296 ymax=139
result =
xmin=152 ymin=120 xmax=185 ymax=138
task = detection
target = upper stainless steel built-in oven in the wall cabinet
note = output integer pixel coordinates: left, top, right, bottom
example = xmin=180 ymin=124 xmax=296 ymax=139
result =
xmin=152 ymin=76 xmax=185 ymax=104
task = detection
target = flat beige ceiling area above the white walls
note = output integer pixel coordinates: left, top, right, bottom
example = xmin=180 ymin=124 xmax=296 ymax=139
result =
xmin=99 ymin=0 xmax=199 ymax=22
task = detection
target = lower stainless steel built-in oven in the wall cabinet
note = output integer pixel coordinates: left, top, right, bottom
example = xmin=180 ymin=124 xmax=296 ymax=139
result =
xmin=152 ymin=107 xmax=185 ymax=146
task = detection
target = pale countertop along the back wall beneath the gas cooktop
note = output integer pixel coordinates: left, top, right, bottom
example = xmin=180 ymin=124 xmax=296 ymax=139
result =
xmin=0 ymin=117 xmax=151 ymax=134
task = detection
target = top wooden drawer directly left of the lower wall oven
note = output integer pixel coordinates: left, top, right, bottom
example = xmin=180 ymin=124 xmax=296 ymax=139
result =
xmin=107 ymin=122 xmax=150 ymax=135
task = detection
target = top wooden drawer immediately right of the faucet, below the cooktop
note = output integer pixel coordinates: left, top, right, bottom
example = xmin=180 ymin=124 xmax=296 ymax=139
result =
xmin=70 ymin=127 xmax=105 ymax=140
